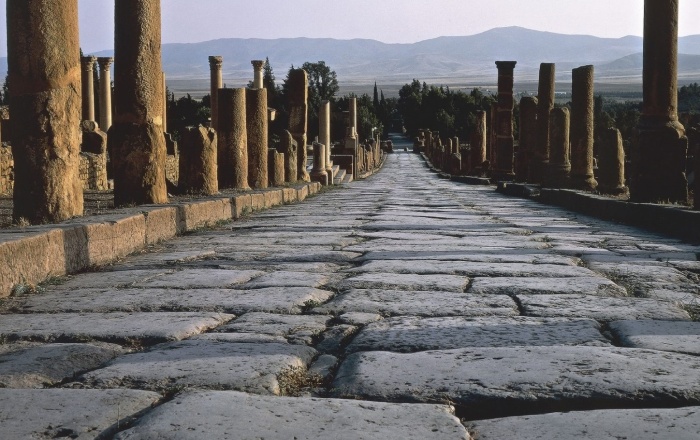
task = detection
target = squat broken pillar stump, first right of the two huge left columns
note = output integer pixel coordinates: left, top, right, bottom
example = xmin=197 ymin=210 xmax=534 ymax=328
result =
xmin=178 ymin=125 xmax=219 ymax=195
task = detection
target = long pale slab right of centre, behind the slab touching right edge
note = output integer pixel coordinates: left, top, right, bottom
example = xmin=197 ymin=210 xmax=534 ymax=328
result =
xmin=516 ymin=295 xmax=690 ymax=321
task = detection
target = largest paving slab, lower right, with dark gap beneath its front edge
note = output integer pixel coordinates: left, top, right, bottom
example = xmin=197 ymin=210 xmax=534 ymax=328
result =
xmin=333 ymin=346 xmax=700 ymax=418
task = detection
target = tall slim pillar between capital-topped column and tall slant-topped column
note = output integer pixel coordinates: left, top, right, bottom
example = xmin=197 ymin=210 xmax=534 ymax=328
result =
xmin=530 ymin=63 xmax=555 ymax=183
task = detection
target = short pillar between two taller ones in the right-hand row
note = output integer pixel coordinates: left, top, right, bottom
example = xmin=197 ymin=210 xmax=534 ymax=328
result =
xmin=542 ymin=107 xmax=571 ymax=188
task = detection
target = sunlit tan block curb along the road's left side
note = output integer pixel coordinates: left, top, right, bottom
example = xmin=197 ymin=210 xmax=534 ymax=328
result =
xmin=0 ymin=182 xmax=321 ymax=297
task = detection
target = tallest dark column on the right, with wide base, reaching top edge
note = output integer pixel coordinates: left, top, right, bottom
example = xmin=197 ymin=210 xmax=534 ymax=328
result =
xmin=630 ymin=0 xmax=688 ymax=203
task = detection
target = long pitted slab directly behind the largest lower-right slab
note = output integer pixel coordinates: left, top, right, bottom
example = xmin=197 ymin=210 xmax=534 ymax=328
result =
xmin=346 ymin=316 xmax=611 ymax=353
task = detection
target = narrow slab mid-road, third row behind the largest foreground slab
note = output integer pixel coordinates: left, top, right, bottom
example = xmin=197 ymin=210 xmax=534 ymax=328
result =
xmin=336 ymin=273 xmax=469 ymax=292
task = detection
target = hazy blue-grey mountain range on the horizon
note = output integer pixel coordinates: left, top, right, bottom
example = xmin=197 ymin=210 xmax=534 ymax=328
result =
xmin=0 ymin=27 xmax=700 ymax=84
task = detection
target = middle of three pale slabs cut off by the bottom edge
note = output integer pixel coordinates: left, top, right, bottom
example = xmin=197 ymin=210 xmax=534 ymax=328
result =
xmin=115 ymin=391 xmax=470 ymax=440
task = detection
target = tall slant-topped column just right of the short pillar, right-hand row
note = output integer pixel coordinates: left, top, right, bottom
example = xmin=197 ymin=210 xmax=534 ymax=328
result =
xmin=571 ymin=66 xmax=598 ymax=191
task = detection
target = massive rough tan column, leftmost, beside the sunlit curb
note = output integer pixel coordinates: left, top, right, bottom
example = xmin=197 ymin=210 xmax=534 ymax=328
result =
xmin=7 ymin=0 xmax=83 ymax=223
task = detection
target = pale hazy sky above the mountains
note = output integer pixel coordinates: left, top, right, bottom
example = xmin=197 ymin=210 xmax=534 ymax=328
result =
xmin=0 ymin=0 xmax=700 ymax=56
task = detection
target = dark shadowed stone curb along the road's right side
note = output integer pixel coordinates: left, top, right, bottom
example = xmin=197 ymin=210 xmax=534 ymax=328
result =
xmin=498 ymin=183 xmax=700 ymax=242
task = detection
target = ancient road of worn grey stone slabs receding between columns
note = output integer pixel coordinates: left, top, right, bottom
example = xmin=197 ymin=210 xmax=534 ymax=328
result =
xmin=0 ymin=136 xmax=700 ymax=440
